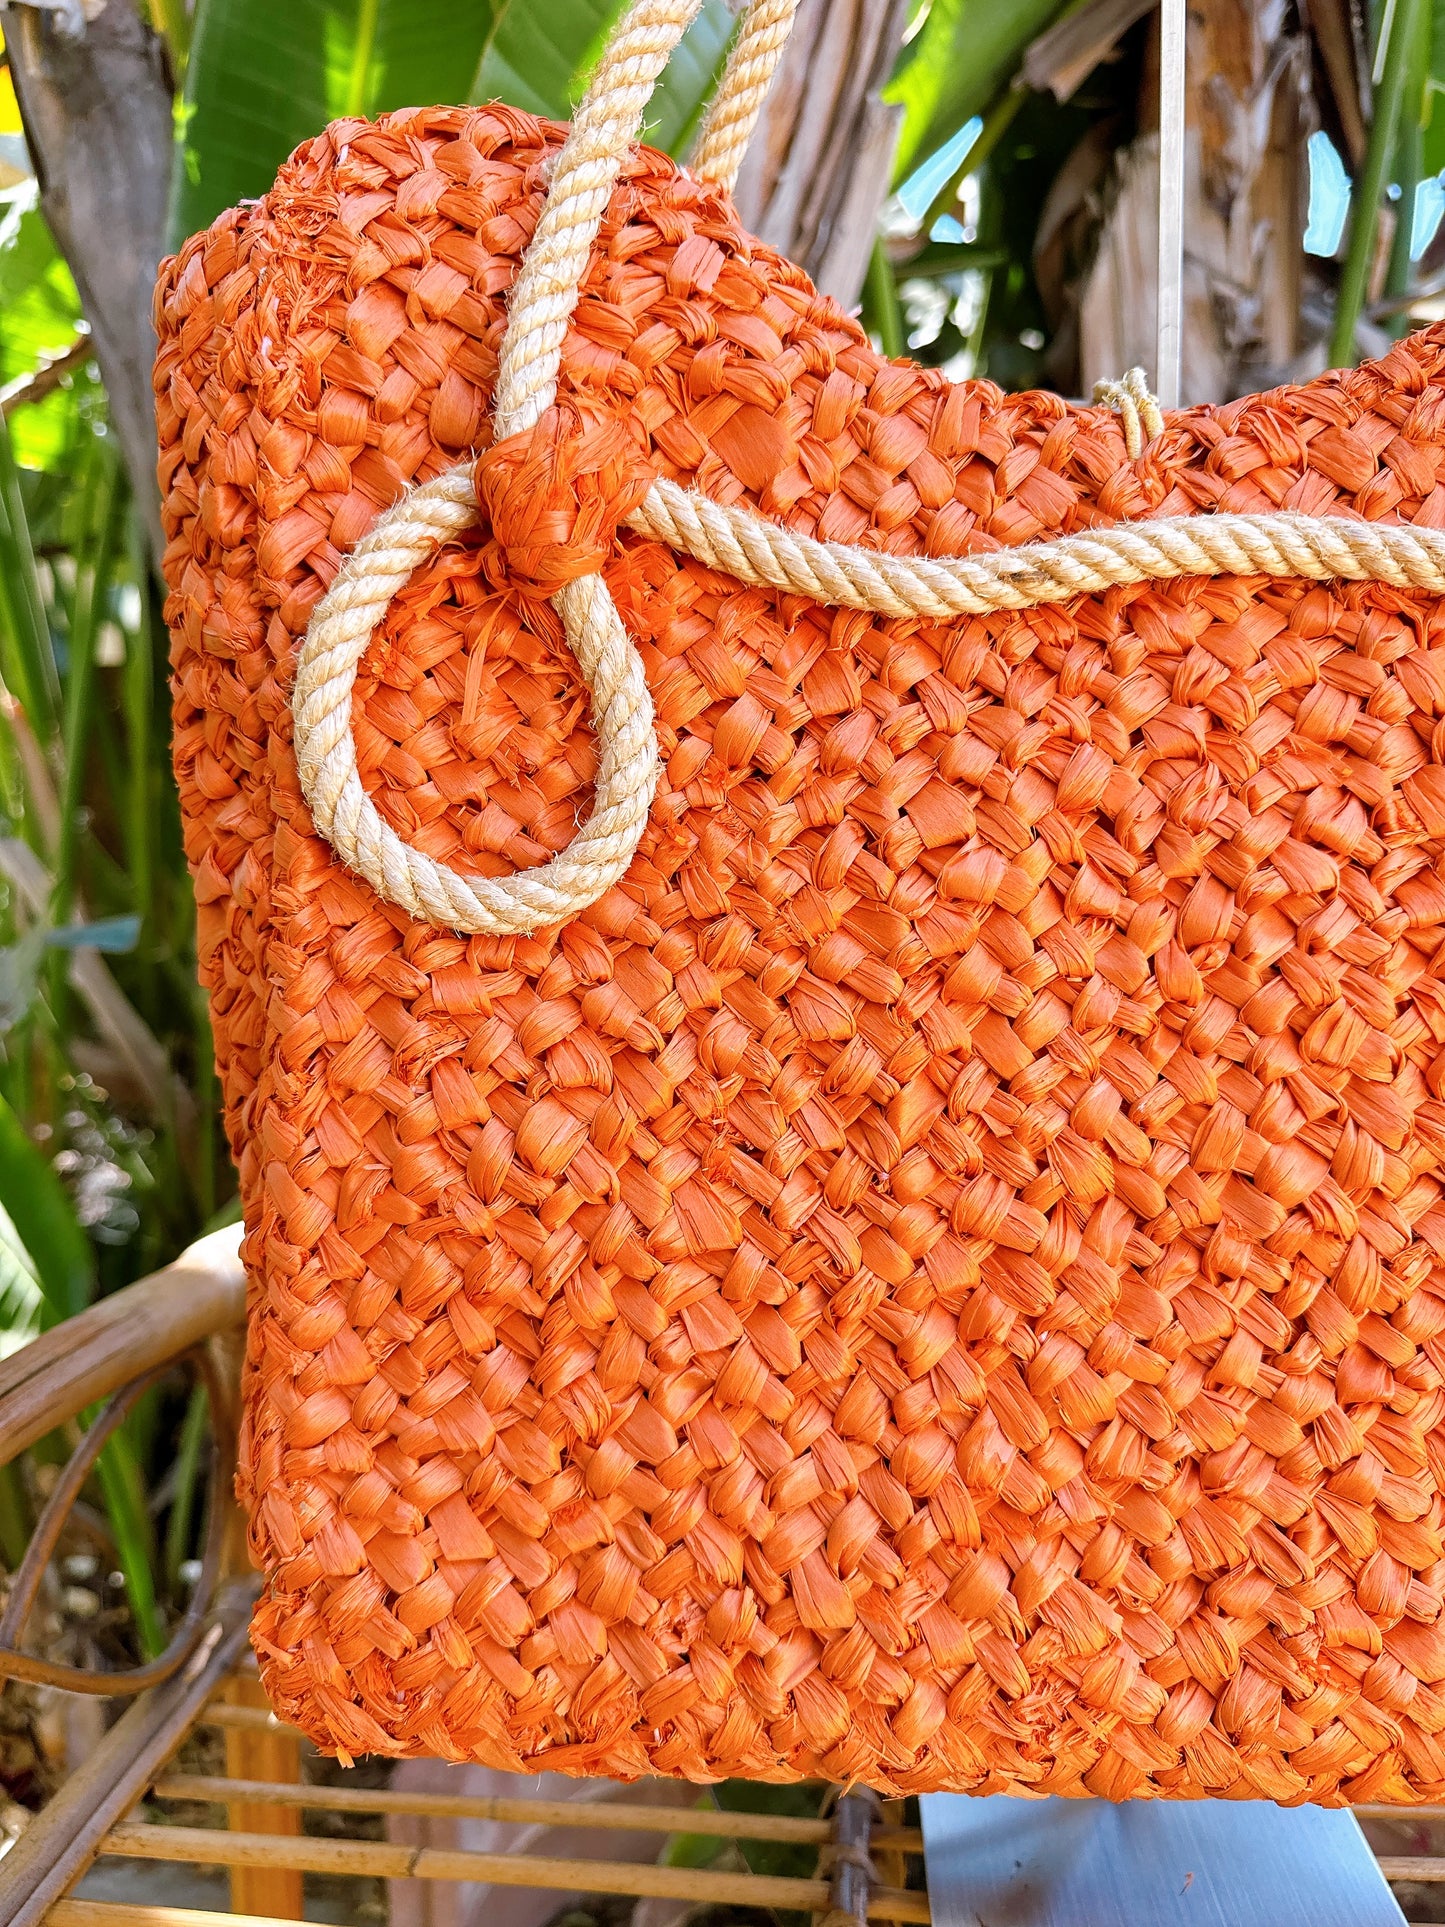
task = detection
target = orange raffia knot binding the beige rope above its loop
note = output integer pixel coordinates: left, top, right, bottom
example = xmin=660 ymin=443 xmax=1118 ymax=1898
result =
xmin=472 ymin=401 xmax=653 ymax=597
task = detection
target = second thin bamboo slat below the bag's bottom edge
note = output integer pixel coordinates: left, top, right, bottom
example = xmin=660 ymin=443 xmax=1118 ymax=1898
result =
xmin=100 ymin=1827 xmax=931 ymax=1927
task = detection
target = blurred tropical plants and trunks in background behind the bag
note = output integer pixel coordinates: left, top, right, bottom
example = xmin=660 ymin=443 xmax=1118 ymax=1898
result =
xmin=0 ymin=0 xmax=1445 ymax=1765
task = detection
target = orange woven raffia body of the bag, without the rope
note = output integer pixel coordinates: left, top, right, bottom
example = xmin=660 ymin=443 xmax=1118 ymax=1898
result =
xmin=156 ymin=108 xmax=1445 ymax=1800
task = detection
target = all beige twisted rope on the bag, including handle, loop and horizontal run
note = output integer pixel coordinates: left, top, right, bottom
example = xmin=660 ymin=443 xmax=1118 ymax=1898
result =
xmin=291 ymin=0 xmax=1445 ymax=935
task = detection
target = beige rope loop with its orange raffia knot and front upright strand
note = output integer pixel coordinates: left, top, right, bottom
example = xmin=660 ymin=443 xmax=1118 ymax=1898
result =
xmin=291 ymin=0 xmax=724 ymax=937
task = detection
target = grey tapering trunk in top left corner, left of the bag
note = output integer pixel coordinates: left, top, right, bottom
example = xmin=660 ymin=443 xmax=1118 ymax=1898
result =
xmin=6 ymin=0 xmax=171 ymax=541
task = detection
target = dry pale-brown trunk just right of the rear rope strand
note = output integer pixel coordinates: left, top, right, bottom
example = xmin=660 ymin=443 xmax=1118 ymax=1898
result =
xmin=736 ymin=0 xmax=909 ymax=308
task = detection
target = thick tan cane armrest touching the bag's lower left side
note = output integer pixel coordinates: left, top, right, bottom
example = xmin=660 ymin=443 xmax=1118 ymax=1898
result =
xmin=0 ymin=1226 xmax=247 ymax=1465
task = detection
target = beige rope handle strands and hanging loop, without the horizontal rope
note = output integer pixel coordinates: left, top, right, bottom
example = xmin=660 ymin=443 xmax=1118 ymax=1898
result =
xmin=291 ymin=0 xmax=796 ymax=937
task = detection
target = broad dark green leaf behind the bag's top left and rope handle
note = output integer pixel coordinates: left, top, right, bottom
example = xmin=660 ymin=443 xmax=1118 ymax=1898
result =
xmin=170 ymin=0 xmax=732 ymax=245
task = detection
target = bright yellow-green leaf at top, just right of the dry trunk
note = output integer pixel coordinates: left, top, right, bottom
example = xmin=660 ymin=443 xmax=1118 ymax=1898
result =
xmin=886 ymin=0 xmax=1065 ymax=181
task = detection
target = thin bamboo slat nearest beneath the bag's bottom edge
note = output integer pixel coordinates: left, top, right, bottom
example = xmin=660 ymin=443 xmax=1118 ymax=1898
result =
xmin=152 ymin=1773 xmax=923 ymax=1854
